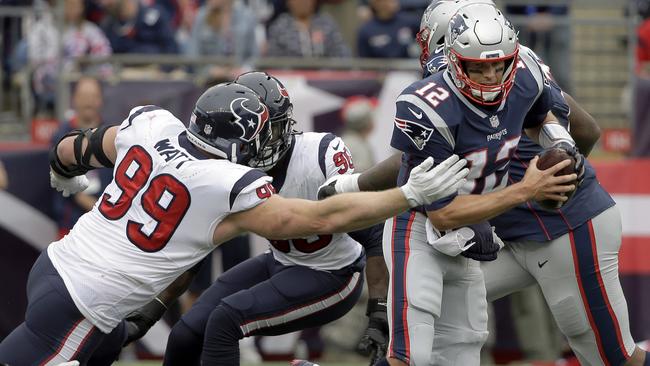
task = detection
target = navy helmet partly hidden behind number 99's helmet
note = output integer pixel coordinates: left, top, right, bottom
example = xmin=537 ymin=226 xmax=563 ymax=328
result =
xmin=235 ymin=71 xmax=294 ymax=171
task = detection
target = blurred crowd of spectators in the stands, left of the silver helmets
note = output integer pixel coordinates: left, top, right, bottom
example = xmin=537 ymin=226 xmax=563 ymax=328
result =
xmin=0 ymin=0 xmax=428 ymax=111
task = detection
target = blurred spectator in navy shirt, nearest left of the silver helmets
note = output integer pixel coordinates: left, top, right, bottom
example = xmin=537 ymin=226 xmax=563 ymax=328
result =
xmin=357 ymin=0 xmax=420 ymax=58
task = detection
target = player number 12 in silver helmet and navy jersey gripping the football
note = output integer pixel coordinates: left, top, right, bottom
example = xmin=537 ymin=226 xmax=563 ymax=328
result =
xmin=322 ymin=3 xmax=577 ymax=365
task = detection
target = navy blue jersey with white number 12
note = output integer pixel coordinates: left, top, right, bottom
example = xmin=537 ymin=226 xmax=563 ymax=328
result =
xmin=391 ymin=49 xmax=551 ymax=211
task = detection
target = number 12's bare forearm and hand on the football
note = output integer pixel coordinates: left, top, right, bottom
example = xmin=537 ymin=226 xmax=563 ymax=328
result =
xmin=427 ymin=156 xmax=576 ymax=230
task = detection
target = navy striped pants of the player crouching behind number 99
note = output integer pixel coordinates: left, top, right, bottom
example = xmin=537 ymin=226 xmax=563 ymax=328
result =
xmin=164 ymin=253 xmax=365 ymax=366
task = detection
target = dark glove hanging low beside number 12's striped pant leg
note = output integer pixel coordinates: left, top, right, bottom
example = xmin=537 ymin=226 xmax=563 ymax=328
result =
xmin=357 ymin=299 xmax=388 ymax=365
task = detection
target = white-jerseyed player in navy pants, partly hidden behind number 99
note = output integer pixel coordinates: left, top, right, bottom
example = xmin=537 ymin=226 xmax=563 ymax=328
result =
xmin=158 ymin=72 xmax=386 ymax=365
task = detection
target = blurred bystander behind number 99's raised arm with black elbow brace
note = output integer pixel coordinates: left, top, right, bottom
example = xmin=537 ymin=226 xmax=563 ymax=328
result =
xmin=52 ymin=77 xmax=112 ymax=237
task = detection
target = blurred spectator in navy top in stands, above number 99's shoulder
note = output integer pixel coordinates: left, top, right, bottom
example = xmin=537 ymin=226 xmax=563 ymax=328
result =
xmin=103 ymin=0 xmax=178 ymax=54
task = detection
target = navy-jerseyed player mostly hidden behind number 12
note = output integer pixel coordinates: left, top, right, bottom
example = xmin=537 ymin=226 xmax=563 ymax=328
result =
xmin=323 ymin=0 xmax=650 ymax=365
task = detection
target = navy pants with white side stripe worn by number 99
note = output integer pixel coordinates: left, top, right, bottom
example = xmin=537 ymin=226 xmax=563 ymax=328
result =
xmin=0 ymin=252 xmax=126 ymax=366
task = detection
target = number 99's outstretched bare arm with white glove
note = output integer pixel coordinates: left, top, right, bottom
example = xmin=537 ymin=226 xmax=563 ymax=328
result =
xmin=214 ymin=155 xmax=468 ymax=243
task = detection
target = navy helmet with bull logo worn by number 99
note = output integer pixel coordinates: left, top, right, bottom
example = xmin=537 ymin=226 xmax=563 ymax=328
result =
xmin=187 ymin=83 xmax=271 ymax=164
